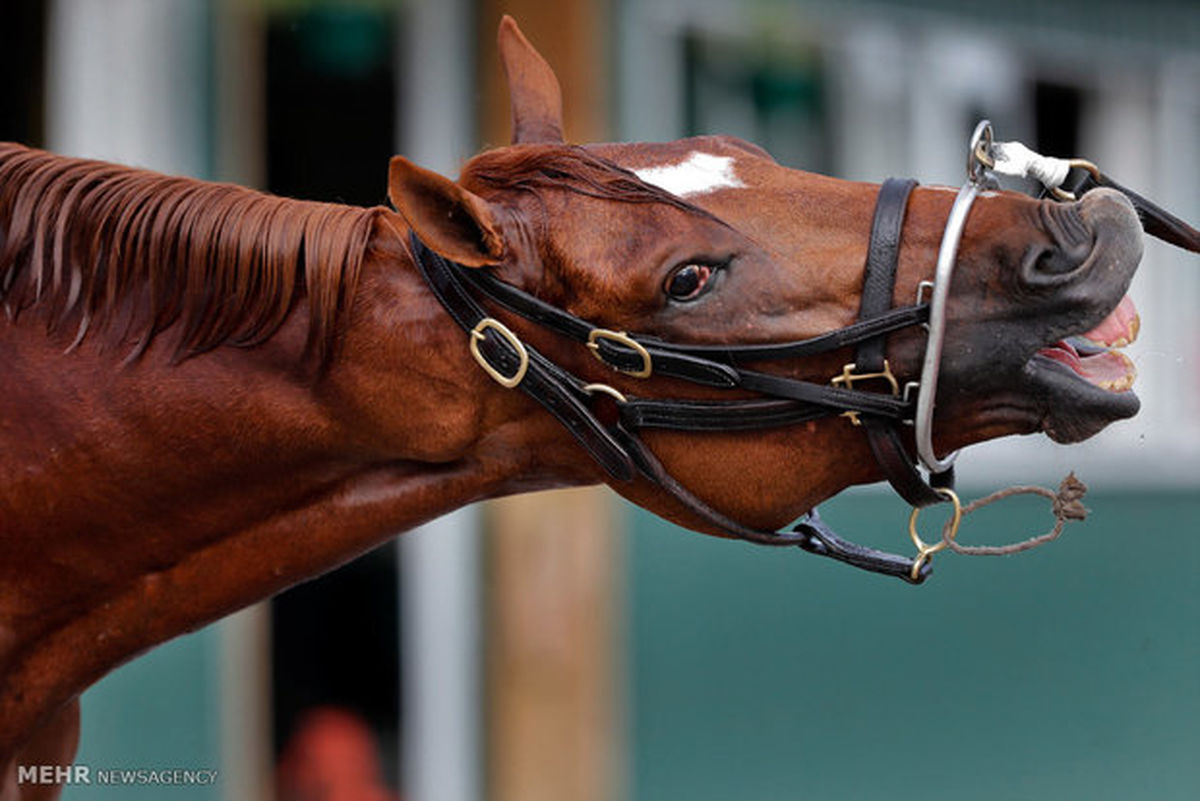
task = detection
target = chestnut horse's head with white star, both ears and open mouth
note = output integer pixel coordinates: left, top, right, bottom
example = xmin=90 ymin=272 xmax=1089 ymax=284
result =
xmin=390 ymin=15 xmax=1141 ymax=534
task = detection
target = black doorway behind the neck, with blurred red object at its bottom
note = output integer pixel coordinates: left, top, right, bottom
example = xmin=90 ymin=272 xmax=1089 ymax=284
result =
xmin=265 ymin=2 xmax=401 ymax=787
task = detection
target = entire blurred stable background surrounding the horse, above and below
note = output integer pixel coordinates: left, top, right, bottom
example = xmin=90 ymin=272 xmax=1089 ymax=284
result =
xmin=0 ymin=0 xmax=1200 ymax=801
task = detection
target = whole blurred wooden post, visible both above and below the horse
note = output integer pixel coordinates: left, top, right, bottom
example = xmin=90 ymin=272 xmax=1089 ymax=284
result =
xmin=480 ymin=0 xmax=620 ymax=801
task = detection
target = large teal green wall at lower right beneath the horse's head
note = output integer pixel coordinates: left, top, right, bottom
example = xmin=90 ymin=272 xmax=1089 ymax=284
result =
xmin=628 ymin=493 xmax=1200 ymax=801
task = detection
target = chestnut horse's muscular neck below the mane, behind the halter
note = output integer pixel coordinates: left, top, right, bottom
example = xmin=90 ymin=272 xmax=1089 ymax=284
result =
xmin=0 ymin=215 xmax=600 ymax=753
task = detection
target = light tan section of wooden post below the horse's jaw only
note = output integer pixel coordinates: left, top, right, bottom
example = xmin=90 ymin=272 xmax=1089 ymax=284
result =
xmin=486 ymin=488 xmax=619 ymax=801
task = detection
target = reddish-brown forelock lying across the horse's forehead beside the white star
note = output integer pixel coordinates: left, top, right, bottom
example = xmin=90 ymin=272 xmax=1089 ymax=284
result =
xmin=460 ymin=144 xmax=725 ymax=225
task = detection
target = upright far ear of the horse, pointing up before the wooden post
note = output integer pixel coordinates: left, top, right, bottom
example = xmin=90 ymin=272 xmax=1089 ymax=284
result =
xmin=498 ymin=14 xmax=563 ymax=145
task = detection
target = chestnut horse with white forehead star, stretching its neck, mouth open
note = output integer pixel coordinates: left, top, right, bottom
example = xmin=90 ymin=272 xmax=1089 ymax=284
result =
xmin=0 ymin=19 xmax=1161 ymax=801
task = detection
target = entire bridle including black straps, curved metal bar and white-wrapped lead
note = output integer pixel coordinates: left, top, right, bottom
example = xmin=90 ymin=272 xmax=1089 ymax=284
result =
xmin=409 ymin=121 xmax=1196 ymax=584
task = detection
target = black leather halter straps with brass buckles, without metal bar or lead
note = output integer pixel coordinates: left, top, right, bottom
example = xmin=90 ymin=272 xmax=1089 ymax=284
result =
xmin=409 ymin=181 xmax=942 ymax=582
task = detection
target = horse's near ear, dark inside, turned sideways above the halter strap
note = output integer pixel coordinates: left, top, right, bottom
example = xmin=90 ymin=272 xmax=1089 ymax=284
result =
xmin=388 ymin=156 xmax=504 ymax=267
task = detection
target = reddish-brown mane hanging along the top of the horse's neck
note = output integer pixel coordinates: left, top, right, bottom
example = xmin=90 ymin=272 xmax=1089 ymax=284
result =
xmin=0 ymin=144 xmax=380 ymax=363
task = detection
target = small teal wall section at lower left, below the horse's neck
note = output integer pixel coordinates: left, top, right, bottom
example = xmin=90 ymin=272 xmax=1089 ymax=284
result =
xmin=62 ymin=626 xmax=222 ymax=801
